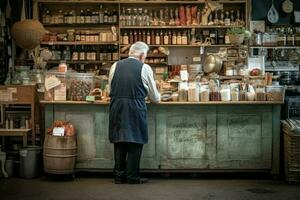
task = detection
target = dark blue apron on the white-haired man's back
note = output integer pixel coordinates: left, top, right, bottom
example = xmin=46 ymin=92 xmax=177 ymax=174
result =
xmin=109 ymin=58 xmax=148 ymax=144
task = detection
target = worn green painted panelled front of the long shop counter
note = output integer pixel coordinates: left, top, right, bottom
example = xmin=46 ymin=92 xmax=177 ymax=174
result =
xmin=41 ymin=101 xmax=282 ymax=175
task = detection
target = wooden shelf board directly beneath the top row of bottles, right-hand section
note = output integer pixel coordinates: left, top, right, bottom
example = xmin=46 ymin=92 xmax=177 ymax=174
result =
xmin=120 ymin=25 xmax=243 ymax=29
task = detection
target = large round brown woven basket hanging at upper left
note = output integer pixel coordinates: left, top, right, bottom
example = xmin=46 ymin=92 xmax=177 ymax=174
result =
xmin=11 ymin=19 xmax=46 ymax=50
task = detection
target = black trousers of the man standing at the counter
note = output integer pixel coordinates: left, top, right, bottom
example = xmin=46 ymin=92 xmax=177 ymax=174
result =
xmin=114 ymin=142 xmax=143 ymax=181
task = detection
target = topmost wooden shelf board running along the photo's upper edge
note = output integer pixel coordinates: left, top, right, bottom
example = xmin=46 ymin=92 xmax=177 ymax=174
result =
xmin=37 ymin=0 xmax=247 ymax=4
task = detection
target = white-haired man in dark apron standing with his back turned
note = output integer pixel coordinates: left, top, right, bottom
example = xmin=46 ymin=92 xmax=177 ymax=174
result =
xmin=109 ymin=42 xmax=160 ymax=184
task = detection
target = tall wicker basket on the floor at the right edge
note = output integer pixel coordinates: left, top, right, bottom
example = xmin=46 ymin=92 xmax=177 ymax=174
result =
xmin=283 ymin=122 xmax=300 ymax=184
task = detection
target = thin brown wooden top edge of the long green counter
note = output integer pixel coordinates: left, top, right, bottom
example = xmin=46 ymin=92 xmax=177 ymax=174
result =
xmin=40 ymin=101 xmax=284 ymax=105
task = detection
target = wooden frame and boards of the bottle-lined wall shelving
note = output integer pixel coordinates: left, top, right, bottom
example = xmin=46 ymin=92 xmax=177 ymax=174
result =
xmin=33 ymin=0 xmax=249 ymax=73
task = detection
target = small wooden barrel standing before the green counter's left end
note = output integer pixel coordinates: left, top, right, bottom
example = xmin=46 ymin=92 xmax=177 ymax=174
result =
xmin=43 ymin=134 xmax=77 ymax=174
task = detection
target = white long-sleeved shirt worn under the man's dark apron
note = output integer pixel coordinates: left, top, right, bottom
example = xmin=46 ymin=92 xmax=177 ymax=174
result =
xmin=108 ymin=57 xmax=160 ymax=103
